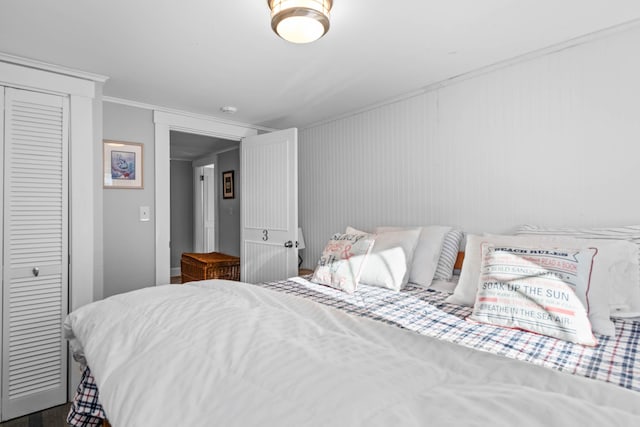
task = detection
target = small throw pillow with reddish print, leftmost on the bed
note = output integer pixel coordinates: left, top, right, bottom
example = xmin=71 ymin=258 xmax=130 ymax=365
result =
xmin=311 ymin=233 xmax=374 ymax=294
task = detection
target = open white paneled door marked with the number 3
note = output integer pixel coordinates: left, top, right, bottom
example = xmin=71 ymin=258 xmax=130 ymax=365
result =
xmin=240 ymin=128 xmax=298 ymax=283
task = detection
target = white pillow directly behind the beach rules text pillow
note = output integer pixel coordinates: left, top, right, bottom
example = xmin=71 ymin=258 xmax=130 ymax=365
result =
xmin=446 ymin=234 xmax=628 ymax=336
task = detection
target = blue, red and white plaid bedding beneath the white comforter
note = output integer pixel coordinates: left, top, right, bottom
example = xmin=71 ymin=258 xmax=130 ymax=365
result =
xmin=67 ymin=278 xmax=640 ymax=426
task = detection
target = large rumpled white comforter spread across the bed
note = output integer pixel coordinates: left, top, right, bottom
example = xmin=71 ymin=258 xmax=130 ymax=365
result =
xmin=65 ymin=280 xmax=640 ymax=427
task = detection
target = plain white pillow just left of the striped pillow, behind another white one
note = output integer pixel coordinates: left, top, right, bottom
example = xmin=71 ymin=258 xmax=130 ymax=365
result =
xmin=376 ymin=225 xmax=450 ymax=287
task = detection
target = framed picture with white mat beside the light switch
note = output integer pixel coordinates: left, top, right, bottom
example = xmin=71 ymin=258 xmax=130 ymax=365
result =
xmin=102 ymin=140 xmax=142 ymax=189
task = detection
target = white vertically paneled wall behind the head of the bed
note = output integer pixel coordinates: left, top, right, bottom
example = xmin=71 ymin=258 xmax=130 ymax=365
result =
xmin=299 ymin=27 xmax=640 ymax=267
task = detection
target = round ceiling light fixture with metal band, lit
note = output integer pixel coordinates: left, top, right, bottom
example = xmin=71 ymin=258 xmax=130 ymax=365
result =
xmin=267 ymin=0 xmax=333 ymax=43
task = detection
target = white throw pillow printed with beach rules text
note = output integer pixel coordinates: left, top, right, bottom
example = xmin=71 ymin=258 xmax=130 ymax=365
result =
xmin=470 ymin=243 xmax=597 ymax=346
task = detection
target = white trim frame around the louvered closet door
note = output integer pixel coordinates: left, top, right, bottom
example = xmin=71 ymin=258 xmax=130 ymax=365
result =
xmin=0 ymin=53 xmax=108 ymax=409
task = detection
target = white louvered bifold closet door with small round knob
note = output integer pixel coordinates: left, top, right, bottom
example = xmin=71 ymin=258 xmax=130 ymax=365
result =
xmin=2 ymin=88 xmax=69 ymax=420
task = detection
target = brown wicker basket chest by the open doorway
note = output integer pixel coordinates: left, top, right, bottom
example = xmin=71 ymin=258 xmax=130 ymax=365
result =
xmin=180 ymin=252 xmax=240 ymax=283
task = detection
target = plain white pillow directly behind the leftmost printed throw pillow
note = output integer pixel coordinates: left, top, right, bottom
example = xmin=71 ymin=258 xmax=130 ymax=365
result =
xmin=347 ymin=227 xmax=420 ymax=291
